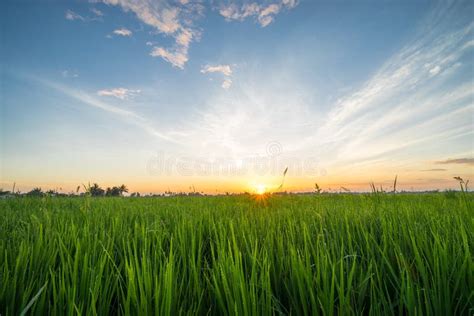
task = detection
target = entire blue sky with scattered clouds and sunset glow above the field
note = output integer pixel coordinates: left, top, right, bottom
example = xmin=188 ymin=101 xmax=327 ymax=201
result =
xmin=0 ymin=0 xmax=474 ymax=194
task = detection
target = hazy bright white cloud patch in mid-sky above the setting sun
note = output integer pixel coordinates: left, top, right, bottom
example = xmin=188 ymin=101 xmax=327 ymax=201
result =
xmin=168 ymin=75 xmax=310 ymax=159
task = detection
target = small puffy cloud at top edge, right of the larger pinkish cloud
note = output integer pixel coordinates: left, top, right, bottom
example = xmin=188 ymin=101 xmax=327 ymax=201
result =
xmin=219 ymin=0 xmax=298 ymax=27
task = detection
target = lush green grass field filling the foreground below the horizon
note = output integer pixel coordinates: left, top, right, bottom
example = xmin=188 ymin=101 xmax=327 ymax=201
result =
xmin=0 ymin=193 xmax=474 ymax=315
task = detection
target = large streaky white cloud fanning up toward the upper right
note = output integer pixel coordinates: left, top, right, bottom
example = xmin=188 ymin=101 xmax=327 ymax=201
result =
xmin=300 ymin=2 xmax=474 ymax=164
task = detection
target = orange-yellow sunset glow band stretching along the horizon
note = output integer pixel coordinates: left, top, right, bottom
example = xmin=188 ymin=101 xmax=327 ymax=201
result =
xmin=0 ymin=165 xmax=474 ymax=195
